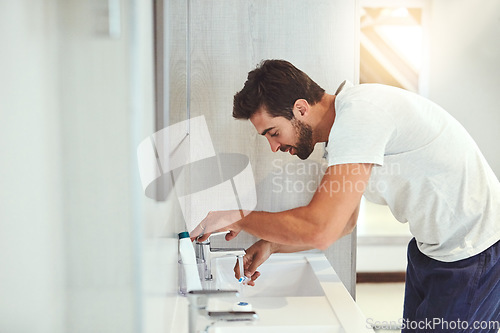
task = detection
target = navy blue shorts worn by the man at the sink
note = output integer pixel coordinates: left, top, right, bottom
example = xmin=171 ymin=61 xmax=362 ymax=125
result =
xmin=402 ymin=239 xmax=500 ymax=333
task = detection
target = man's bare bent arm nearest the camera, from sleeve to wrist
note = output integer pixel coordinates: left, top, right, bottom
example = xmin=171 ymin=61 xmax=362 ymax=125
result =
xmin=237 ymin=163 xmax=372 ymax=249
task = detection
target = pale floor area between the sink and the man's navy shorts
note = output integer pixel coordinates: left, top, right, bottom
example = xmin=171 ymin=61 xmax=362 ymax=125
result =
xmin=356 ymin=283 xmax=404 ymax=333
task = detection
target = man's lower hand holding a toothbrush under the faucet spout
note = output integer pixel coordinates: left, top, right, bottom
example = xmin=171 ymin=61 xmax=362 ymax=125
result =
xmin=234 ymin=240 xmax=274 ymax=286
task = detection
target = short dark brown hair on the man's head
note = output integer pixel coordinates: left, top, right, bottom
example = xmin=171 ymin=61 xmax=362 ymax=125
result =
xmin=233 ymin=60 xmax=325 ymax=120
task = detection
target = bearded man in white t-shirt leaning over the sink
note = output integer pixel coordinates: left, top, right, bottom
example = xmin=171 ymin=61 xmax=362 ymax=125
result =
xmin=193 ymin=60 xmax=500 ymax=332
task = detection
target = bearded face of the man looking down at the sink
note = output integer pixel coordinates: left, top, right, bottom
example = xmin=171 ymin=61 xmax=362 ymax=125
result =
xmin=250 ymin=109 xmax=314 ymax=160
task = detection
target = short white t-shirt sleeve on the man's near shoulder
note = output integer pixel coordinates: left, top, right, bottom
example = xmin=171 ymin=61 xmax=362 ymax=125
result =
xmin=326 ymin=100 xmax=396 ymax=166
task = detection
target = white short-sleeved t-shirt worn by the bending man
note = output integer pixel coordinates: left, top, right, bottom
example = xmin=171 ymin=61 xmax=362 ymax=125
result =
xmin=326 ymin=84 xmax=500 ymax=262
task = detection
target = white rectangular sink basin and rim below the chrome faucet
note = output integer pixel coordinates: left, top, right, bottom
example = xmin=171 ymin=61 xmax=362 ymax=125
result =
xmin=202 ymin=252 xmax=373 ymax=333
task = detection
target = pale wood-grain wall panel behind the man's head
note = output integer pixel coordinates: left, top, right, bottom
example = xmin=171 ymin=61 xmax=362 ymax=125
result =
xmin=167 ymin=0 xmax=358 ymax=294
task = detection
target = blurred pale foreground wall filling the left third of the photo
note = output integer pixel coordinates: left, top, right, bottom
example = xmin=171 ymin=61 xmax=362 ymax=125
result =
xmin=0 ymin=0 xmax=168 ymax=333
